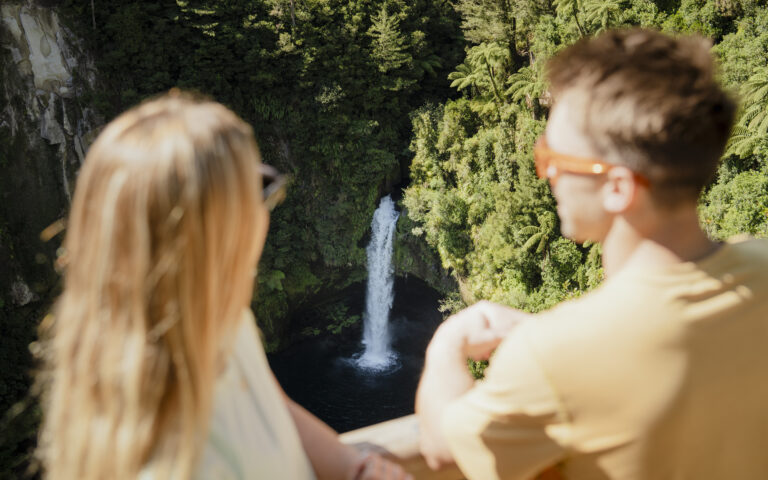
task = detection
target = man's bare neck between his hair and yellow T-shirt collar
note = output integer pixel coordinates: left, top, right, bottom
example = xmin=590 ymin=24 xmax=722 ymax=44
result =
xmin=603 ymin=204 xmax=719 ymax=278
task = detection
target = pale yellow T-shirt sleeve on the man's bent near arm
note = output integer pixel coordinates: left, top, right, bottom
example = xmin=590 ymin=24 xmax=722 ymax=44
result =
xmin=440 ymin=326 xmax=570 ymax=480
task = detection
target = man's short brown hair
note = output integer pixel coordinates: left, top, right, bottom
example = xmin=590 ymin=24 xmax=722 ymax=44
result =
xmin=548 ymin=29 xmax=735 ymax=206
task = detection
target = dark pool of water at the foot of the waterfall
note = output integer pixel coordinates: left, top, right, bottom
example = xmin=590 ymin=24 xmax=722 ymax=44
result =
xmin=269 ymin=278 xmax=442 ymax=432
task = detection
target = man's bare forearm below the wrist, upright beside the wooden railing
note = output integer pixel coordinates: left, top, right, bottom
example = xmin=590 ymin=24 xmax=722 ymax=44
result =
xmin=416 ymin=336 xmax=474 ymax=468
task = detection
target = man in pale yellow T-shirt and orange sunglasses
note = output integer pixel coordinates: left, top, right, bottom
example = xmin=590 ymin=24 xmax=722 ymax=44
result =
xmin=416 ymin=30 xmax=768 ymax=480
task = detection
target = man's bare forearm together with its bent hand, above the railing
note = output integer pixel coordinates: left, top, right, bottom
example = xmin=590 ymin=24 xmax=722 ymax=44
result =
xmin=416 ymin=301 xmax=530 ymax=469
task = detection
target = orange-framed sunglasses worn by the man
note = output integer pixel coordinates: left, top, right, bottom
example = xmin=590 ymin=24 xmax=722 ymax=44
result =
xmin=533 ymin=135 xmax=648 ymax=186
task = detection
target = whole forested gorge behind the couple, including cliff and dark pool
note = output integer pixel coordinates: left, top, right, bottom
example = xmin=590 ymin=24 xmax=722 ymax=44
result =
xmin=6 ymin=0 xmax=768 ymax=478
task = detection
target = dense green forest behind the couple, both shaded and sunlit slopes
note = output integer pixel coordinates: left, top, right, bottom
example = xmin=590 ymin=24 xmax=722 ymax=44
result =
xmin=0 ymin=0 xmax=768 ymax=477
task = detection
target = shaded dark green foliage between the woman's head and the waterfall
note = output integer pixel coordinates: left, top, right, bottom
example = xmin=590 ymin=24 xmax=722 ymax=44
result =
xmin=58 ymin=0 xmax=463 ymax=343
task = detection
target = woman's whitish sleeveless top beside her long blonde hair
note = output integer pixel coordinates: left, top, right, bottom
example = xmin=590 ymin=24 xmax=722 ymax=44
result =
xmin=193 ymin=311 xmax=315 ymax=480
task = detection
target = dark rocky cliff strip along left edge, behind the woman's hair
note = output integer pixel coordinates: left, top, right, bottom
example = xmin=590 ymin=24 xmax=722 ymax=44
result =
xmin=0 ymin=6 xmax=102 ymax=472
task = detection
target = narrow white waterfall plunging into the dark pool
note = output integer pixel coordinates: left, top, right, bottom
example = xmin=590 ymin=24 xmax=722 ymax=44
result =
xmin=357 ymin=195 xmax=400 ymax=370
